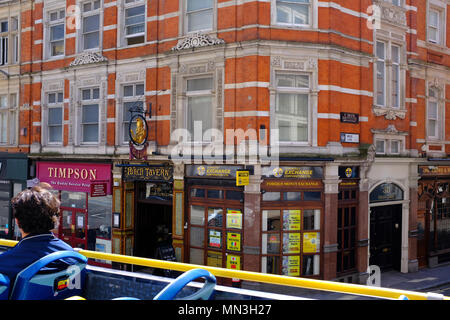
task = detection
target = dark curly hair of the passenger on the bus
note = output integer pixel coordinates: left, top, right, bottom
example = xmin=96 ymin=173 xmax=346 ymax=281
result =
xmin=11 ymin=183 xmax=60 ymax=234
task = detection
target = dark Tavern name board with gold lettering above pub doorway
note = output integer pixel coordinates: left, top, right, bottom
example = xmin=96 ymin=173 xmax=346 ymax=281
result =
xmin=122 ymin=165 xmax=173 ymax=181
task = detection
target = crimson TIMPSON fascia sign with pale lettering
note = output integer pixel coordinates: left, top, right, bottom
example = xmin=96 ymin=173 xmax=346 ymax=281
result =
xmin=36 ymin=162 xmax=111 ymax=194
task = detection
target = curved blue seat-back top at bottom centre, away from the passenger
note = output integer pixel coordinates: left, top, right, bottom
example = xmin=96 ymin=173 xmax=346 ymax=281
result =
xmin=153 ymin=269 xmax=216 ymax=300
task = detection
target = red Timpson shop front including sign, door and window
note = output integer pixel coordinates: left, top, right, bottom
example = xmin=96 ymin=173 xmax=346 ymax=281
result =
xmin=36 ymin=162 xmax=112 ymax=266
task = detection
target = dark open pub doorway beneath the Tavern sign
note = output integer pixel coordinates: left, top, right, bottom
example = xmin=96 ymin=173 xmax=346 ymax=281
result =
xmin=134 ymin=181 xmax=172 ymax=274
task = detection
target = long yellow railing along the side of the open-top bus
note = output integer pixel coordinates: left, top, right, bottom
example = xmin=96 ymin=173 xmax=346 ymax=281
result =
xmin=0 ymin=239 xmax=450 ymax=300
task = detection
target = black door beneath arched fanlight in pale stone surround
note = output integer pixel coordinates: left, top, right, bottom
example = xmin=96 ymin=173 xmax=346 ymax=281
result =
xmin=370 ymin=205 xmax=402 ymax=271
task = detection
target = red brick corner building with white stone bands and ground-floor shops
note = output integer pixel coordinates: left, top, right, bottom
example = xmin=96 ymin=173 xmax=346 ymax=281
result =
xmin=0 ymin=0 xmax=450 ymax=282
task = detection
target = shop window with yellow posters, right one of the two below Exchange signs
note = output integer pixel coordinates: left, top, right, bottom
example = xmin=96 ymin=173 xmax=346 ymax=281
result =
xmin=261 ymin=208 xmax=321 ymax=276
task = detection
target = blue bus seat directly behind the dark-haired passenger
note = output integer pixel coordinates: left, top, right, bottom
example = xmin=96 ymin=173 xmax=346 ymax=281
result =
xmin=10 ymin=251 xmax=87 ymax=300
